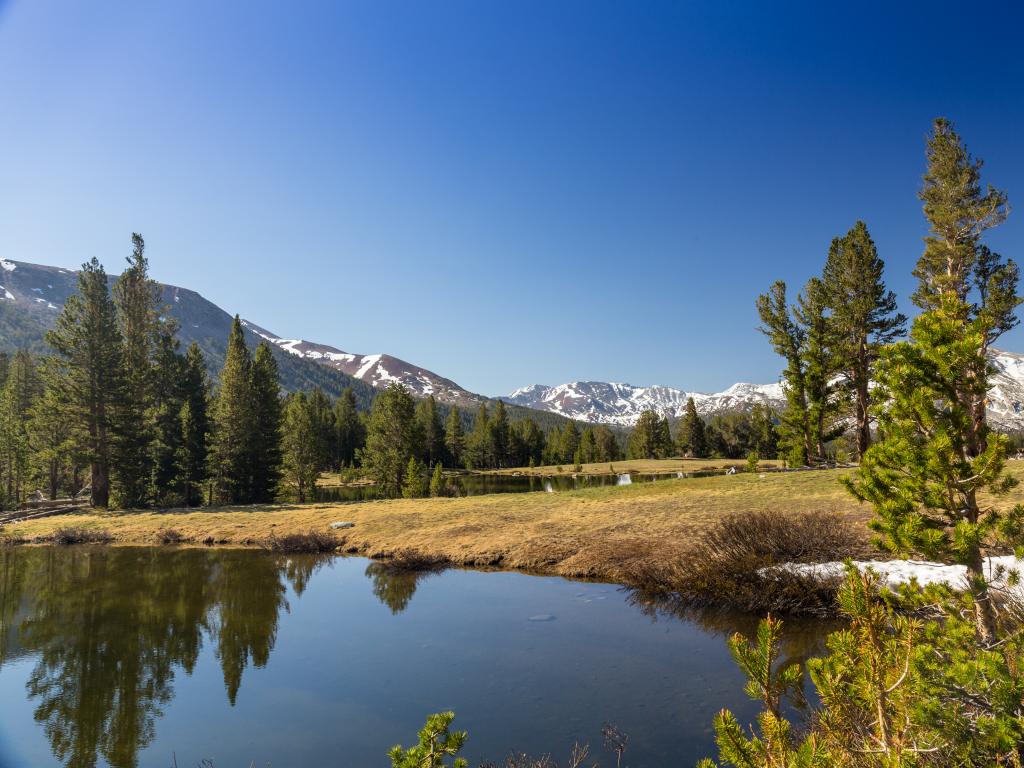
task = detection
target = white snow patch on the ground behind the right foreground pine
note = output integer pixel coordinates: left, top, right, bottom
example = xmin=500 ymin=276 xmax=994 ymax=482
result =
xmin=767 ymin=555 xmax=1024 ymax=596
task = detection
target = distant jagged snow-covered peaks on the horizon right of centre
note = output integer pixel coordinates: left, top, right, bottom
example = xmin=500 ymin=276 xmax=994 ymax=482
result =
xmin=502 ymin=381 xmax=784 ymax=426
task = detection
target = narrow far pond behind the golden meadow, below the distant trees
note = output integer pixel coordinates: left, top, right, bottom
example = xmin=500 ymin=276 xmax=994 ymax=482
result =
xmin=316 ymin=470 xmax=724 ymax=502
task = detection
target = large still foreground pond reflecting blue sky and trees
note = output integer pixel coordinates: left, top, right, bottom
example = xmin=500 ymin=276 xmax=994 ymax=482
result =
xmin=0 ymin=547 xmax=823 ymax=768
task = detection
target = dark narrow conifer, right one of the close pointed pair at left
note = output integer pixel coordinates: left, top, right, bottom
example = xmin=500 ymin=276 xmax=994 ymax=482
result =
xmin=251 ymin=341 xmax=282 ymax=504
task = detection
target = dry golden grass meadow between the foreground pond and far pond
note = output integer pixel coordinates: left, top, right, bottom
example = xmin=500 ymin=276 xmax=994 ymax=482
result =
xmin=9 ymin=462 xmax=1024 ymax=582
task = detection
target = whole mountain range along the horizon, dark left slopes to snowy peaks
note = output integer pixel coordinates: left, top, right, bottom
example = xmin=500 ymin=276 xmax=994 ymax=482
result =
xmin=6 ymin=259 xmax=1024 ymax=430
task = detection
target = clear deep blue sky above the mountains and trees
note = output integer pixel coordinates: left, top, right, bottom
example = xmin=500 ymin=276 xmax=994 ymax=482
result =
xmin=0 ymin=0 xmax=1024 ymax=394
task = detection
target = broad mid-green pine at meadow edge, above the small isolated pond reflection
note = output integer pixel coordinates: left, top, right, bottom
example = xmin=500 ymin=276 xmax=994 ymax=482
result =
xmin=362 ymin=383 xmax=419 ymax=498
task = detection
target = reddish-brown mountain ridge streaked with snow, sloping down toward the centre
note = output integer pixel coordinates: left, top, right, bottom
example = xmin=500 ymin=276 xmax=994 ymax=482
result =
xmin=242 ymin=321 xmax=486 ymax=406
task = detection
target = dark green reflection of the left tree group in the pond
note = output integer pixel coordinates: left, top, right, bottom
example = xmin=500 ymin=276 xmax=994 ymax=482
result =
xmin=0 ymin=547 xmax=324 ymax=768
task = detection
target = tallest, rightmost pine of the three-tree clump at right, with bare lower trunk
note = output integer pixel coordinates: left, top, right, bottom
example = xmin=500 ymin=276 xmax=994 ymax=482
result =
xmin=822 ymin=221 xmax=906 ymax=459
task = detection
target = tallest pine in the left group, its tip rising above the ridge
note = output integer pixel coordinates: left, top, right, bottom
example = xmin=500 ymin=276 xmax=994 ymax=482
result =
xmin=114 ymin=232 xmax=160 ymax=508
